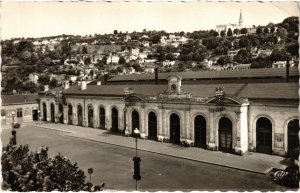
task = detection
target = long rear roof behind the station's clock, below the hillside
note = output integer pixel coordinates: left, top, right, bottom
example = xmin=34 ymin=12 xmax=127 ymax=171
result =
xmin=108 ymin=67 xmax=299 ymax=82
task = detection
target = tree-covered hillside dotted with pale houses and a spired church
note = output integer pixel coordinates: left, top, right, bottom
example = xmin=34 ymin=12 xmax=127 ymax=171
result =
xmin=1 ymin=12 xmax=299 ymax=94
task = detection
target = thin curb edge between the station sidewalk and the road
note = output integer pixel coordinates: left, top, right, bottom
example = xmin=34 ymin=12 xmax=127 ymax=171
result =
xmin=65 ymin=135 xmax=272 ymax=175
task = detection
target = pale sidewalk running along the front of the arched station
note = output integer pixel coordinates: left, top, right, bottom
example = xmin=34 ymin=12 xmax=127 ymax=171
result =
xmin=33 ymin=122 xmax=286 ymax=174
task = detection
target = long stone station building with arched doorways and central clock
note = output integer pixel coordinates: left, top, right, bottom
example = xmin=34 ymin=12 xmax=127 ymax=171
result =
xmin=39 ymin=68 xmax=299 ymax=156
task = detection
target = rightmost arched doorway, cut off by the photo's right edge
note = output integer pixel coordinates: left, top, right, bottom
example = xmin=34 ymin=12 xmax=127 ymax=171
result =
xmin=288 ymin=119 xmax=299 ymax=156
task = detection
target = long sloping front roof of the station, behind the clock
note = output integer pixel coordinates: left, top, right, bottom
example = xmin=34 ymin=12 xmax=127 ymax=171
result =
xmin=63 ymin=83 xmax=299 ymax=100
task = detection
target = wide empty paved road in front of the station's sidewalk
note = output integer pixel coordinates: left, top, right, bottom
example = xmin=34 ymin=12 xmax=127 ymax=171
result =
xmin=2 ymin=126 xmax=288 ymax=191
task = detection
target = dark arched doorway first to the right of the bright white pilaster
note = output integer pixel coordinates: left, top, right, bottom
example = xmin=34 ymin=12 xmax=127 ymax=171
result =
xmin=256 ymin=117 xmax=272 ymax=154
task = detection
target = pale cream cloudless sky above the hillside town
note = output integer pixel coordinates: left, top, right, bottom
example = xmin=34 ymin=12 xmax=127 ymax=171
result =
xmin=0 ymin=1 xmax=299 ymax=39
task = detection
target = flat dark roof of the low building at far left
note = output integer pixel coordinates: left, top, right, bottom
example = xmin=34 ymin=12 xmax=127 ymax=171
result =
xmin=1 ymin=94 xmax=39 ymax=106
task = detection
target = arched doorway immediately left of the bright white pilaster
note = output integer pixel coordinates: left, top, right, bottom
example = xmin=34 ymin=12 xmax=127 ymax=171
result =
xmin=219 ymin=117 xmax=232 ymax=153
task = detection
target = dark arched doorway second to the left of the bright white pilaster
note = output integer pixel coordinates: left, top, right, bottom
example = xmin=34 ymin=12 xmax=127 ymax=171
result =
xmin=194 ymin=115 xmax=206 ymax=148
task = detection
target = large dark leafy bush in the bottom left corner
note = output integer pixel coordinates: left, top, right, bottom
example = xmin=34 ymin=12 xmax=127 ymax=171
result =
xmin=1 ymin=144 xmax=104 ymax=192
